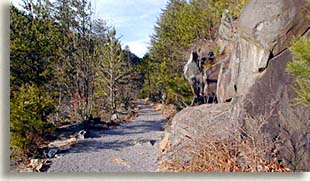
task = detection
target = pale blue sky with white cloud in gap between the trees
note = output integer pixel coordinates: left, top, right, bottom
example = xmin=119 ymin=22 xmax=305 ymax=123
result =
xmin=11 ymin=0 xmax=168 ymax=57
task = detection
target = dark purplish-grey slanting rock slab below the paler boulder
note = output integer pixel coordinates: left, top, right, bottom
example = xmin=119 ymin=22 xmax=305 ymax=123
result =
xmin=233 ymin=46 xmax=310 ymax=171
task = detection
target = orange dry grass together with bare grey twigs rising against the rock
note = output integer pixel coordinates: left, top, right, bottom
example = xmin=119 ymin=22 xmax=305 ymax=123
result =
xmin=160 ymin=107 xmax=293 ymax=172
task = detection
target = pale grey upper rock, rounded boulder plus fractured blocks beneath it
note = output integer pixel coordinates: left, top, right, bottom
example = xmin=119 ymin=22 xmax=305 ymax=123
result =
xmin=217 ymin=0 xmax=309 ymax=102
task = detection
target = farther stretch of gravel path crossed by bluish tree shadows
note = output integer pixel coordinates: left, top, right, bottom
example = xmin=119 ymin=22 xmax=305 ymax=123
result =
xmin=52 ymin=99 xmax=165 ymax=155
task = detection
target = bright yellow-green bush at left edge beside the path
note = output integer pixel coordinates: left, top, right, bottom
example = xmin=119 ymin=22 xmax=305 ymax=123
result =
xmin=10 ymin=85 xmax=54 ymax=156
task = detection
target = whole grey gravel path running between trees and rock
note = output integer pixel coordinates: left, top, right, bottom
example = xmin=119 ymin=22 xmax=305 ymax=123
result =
xmin=48 ymin=101 xmax=164 ymax=172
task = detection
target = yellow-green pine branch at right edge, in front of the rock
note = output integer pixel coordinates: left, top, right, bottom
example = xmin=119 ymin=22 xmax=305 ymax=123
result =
xmin=288 ymin=38 xmax=310 ymax=107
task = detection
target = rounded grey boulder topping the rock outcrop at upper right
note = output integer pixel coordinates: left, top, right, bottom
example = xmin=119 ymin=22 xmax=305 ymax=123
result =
xmin=239 ymin=0 xmax=309 ymax=55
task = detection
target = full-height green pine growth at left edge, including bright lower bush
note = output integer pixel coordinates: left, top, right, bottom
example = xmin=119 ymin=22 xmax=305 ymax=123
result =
xmin=10 ymin=3 xmax=59 ymax=156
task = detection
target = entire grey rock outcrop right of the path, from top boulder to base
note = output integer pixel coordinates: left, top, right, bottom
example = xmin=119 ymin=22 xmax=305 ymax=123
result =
xmin=161 ymin=0 xmax=310 ymax=171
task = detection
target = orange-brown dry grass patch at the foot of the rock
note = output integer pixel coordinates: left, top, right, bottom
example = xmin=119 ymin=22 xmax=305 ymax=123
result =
xmin=161 ymin=138 xmax=290 ymax=172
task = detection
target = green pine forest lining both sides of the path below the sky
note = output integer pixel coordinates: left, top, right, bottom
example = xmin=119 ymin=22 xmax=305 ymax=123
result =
xmin=10 ymin=0 xmax=310 ymax=167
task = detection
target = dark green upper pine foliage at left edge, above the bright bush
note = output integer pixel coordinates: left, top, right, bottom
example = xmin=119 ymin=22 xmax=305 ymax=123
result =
xmin=10 ymin=6 xmax=58 ymax=90
